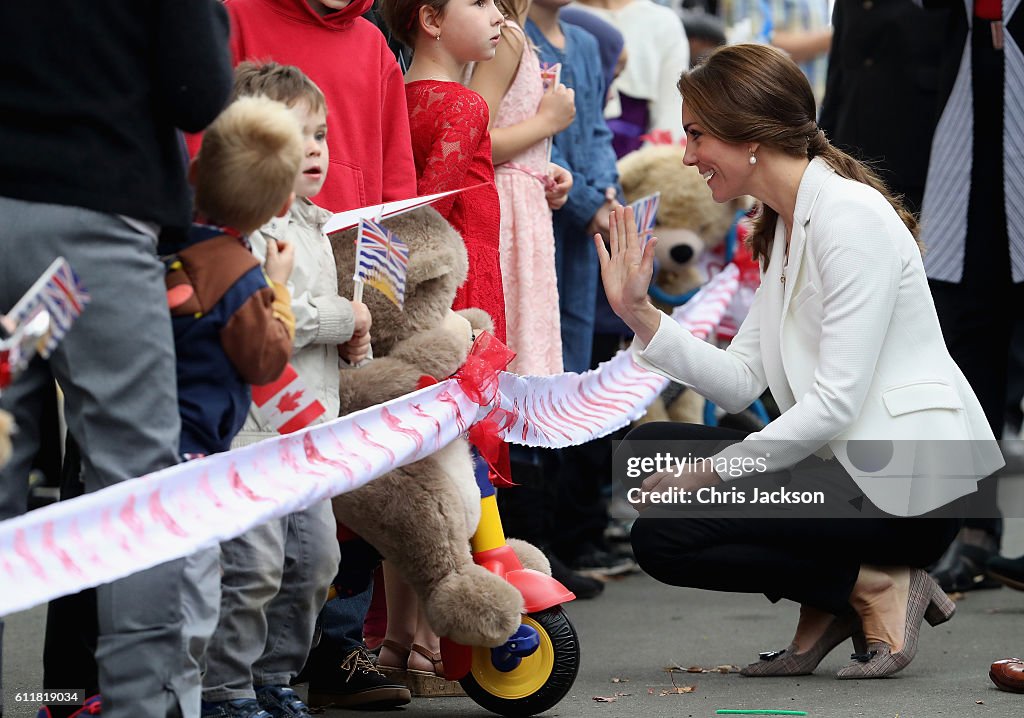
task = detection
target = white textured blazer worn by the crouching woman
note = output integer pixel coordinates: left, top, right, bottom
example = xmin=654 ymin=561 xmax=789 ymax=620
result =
xmin=633 ymin=158 xmax=1004 ymax=516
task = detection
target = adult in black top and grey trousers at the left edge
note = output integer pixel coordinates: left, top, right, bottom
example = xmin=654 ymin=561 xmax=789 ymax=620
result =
xmin=0 ymin=0 xmax=231 ymax=718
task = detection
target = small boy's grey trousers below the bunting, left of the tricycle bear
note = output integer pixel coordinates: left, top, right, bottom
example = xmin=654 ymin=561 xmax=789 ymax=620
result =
xmin=203 ymin=501 xmax=340 ymax=703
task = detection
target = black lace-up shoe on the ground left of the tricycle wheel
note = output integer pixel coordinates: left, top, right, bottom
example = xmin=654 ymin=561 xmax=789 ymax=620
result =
xmin=308 ymin=646 xmax=413 ymax=711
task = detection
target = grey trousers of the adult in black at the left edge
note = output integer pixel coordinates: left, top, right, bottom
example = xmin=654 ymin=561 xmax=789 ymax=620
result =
xmin=0 ymin=198 xmax=192 ymax=718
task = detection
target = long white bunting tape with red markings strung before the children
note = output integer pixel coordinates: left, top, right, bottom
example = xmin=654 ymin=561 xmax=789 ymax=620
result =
xmin=0 ymin=269 xmax=736 ymax=616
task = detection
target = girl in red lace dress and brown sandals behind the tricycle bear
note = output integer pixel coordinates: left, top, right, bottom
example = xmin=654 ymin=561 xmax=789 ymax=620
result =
xmin=378 ymin=0 xmax=507 ymax=695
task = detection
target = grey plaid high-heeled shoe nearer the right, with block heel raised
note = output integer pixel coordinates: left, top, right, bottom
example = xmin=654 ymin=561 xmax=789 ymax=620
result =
xmin=836 ymin=568 xmax=956 ymax=680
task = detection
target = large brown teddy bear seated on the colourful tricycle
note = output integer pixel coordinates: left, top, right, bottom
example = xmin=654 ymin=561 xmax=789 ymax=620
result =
xmin=331 ymin=207 xmax=550 ymax=646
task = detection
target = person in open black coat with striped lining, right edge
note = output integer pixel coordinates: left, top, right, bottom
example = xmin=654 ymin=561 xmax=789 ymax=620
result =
xmin=922 ymin=0 xmax=1024 ymax=590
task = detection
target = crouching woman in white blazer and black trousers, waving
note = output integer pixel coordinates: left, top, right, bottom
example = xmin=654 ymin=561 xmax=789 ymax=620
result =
xmin=595 ymin=45 xmax=1002 ymax=678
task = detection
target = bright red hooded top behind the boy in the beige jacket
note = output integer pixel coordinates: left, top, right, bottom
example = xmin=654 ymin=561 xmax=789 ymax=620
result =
xmin=224 ymin=0 xmax=416 ymax=212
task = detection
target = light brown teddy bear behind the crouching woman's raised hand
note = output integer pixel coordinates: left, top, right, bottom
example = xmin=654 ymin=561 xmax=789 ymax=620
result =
xmin=618 ymin=144 xmax=757 ymax=423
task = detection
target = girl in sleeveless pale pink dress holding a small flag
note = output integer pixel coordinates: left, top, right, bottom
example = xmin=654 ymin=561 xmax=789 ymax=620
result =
xmin=469 ymin=0 xmax=575 ymax=375
